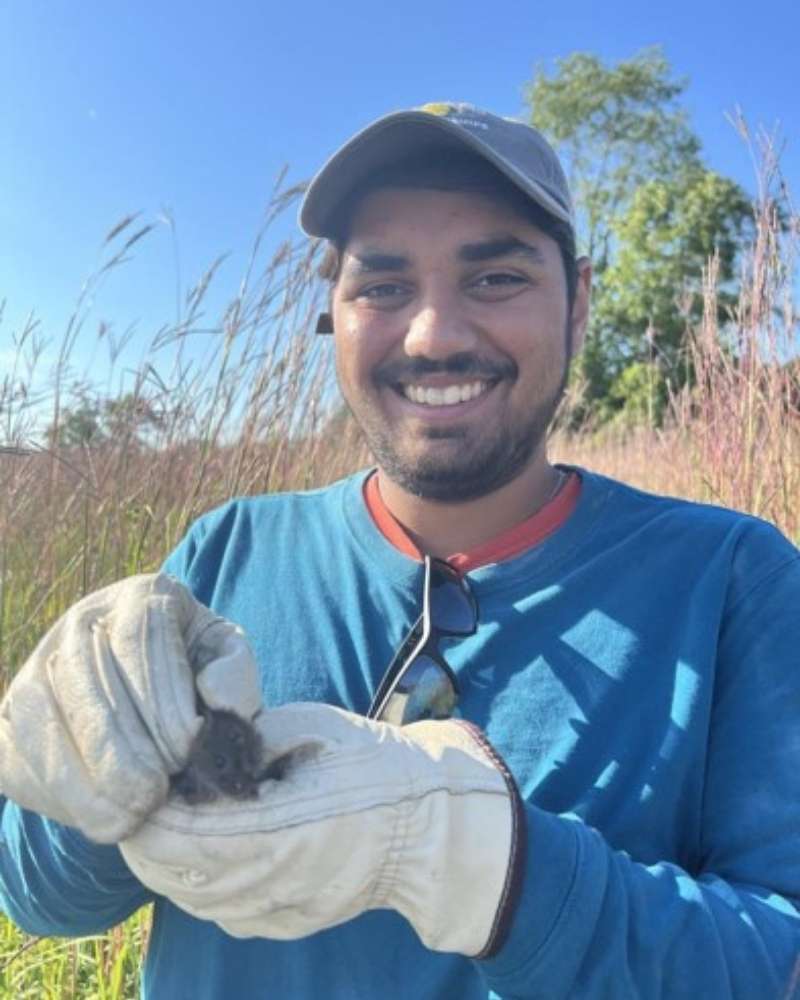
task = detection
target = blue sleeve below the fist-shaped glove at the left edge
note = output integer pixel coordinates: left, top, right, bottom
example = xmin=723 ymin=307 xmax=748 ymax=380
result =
xmin=0 ymin=796 xmax=153 ymax=937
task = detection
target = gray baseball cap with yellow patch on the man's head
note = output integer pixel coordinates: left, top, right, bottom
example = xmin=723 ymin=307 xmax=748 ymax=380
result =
xmin=299 ymin=103 xmax=575 ymax=236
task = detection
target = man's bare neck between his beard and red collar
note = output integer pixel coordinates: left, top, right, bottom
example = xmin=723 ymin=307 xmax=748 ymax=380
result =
xmin=378 ymin=456 xmax=561 ymax=558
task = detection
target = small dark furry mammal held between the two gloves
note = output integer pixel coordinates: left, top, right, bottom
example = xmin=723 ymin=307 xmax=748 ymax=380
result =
xmin=170 ymin=706 xmax=284 ymax=805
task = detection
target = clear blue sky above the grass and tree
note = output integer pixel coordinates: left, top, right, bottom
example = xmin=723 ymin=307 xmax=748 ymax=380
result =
xmin=0 ymin=0 xmax=800 ymax=390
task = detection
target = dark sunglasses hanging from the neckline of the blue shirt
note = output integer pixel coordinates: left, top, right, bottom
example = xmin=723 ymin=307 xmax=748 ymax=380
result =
xmin=367 ymin=556 xmax=478 ymax=726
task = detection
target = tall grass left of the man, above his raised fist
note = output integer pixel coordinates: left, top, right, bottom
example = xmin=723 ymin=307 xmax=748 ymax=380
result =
xmin=0 ymin=181 xmax=365 ymax=688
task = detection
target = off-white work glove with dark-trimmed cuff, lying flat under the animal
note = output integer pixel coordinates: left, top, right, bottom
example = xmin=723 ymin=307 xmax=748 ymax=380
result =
xmin=120 ymin=704 xmax=524 ymax=957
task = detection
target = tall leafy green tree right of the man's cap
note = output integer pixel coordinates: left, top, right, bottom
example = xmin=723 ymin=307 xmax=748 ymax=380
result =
xmin=525 ymin=49 xmax=751 ymax=419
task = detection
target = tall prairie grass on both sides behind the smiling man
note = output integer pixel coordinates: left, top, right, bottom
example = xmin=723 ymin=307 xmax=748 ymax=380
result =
xmin=0 ymin=125 xmax=800 ymax=1000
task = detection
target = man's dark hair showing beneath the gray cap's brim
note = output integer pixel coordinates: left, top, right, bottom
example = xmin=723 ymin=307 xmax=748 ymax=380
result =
xmin=319 ymin=148 xmax=578 ymax=309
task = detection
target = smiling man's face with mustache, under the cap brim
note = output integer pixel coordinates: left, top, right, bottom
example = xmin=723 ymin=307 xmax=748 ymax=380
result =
xmin=332 ymin=189 xmax=589 ymax=502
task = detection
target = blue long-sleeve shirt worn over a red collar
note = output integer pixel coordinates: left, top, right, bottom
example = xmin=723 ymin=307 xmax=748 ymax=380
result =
xmin=0 ymin=471 xmax=800 ymax=1000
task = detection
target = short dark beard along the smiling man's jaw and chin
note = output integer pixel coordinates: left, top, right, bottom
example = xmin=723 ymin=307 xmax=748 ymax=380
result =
xmin=340 ymin=354 xmax=569 ymax=503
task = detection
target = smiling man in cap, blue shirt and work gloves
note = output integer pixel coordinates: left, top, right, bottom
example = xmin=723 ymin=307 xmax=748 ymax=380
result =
xmin=0 ymin=105 xmax=800 ymax=1000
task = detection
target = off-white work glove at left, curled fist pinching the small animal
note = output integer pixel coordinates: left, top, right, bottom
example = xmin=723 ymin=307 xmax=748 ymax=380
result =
xmin=0 ymin=574 xmax=261 ymax=843
